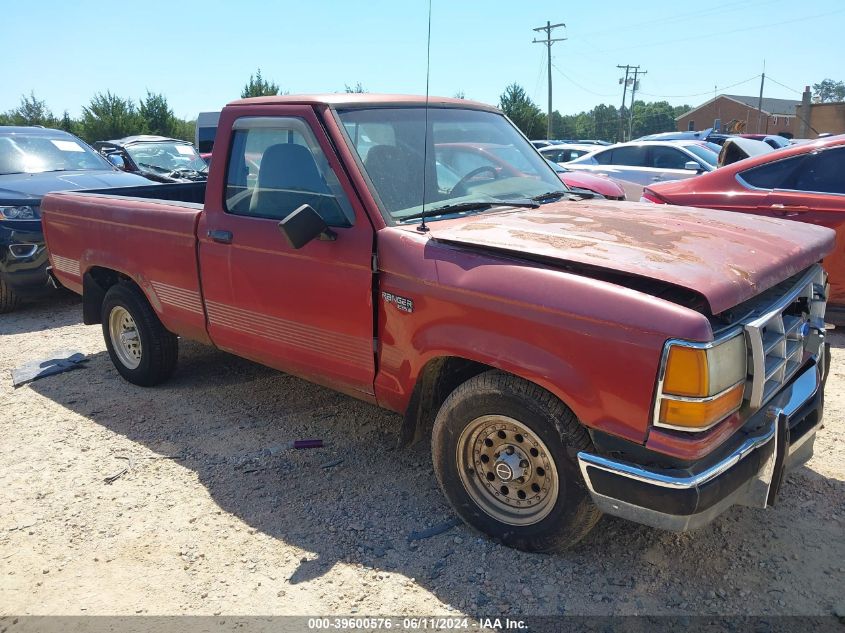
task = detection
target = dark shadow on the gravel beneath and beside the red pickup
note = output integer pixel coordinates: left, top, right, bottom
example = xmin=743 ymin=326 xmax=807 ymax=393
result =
xmin=26 ymin=343 xmax=845 ymax=614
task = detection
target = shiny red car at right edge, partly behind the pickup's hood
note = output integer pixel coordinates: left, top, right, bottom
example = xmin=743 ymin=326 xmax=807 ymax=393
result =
xmin=642 ymin=135 xmax=845 ymax=325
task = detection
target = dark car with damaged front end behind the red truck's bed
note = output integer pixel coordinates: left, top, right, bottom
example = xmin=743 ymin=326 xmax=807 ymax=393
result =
xmin=94 ymin=134 xmax=208 ymax=182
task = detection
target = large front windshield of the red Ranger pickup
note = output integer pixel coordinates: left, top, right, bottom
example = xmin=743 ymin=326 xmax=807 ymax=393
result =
xmin=339 ymin=107 xmax=566 ymax=221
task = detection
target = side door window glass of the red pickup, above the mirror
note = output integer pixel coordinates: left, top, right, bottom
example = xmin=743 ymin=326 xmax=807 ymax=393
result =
xmin=226 ymin=117 xmax=354 ymax=227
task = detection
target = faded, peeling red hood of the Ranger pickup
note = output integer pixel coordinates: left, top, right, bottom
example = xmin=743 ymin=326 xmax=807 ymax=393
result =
xmin=428 ymin=200 xmax=835 ymax=314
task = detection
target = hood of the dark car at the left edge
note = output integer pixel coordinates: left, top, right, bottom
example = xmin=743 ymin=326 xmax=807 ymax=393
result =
xmin=0 ymin=169 xmax=150 ymax=203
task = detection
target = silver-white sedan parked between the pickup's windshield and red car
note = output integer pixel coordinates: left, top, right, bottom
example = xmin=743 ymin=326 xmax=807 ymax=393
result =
xmin=566 ymin=141 xmax=719 ymax=186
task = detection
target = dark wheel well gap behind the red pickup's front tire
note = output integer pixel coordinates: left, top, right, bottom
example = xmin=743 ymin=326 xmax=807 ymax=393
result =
xmin=399 ymin=356 xmax=495 ymax=446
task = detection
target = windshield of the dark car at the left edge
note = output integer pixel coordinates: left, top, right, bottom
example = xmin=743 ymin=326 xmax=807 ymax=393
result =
xmin=0 ymin=132 xmax=113 ymax=175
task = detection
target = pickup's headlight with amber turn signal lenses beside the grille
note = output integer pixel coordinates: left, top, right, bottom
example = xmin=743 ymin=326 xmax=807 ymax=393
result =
xmin=654 ymin=331 xmax=747 ymax=431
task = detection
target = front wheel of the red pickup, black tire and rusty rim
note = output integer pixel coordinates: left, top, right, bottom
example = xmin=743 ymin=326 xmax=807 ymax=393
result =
xmin=432 ymin=371 xmax=601 ymax=552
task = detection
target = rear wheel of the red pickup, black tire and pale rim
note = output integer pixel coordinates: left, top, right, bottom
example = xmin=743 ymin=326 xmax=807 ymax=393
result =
xmin=101 ymin=283 xmax=179 ymax=387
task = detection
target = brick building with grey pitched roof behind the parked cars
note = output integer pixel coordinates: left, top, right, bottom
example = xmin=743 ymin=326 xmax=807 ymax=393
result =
xmin=675 ymin=95 xmax=801 ymax=137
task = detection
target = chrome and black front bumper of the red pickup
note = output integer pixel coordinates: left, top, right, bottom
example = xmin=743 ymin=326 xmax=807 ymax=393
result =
xmin=578 ymin=348 xmax=829 ymax=531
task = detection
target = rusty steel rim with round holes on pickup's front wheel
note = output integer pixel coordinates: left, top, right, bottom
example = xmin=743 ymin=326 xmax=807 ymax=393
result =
xmin=456 ymin=415 xmax=559 ymax=525
